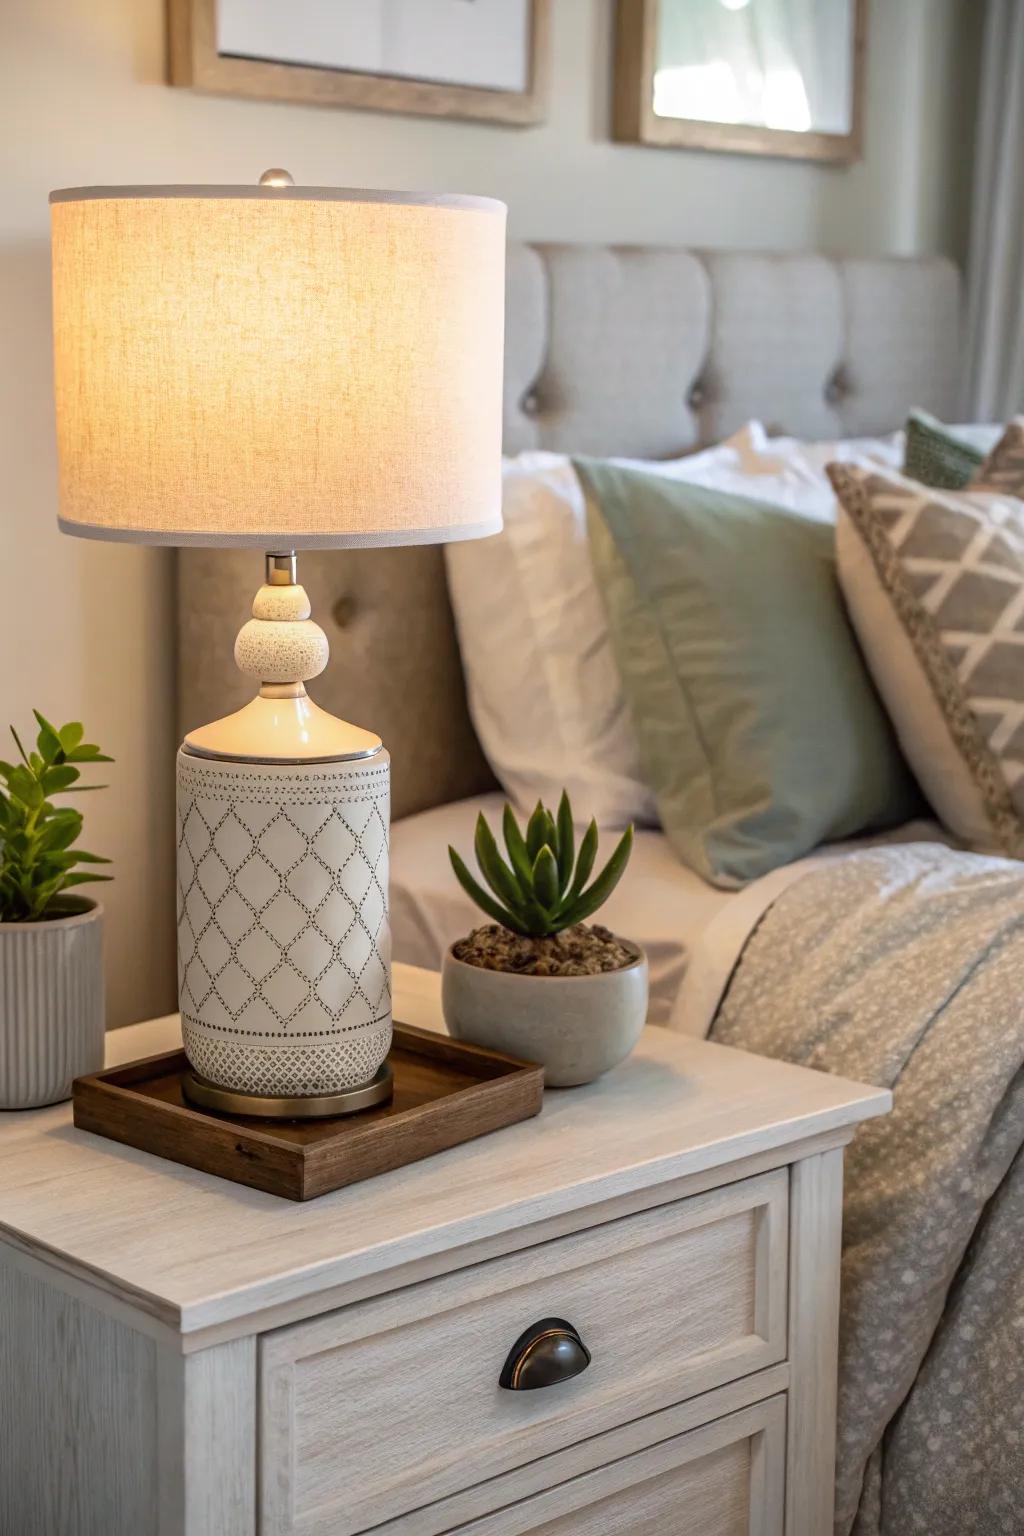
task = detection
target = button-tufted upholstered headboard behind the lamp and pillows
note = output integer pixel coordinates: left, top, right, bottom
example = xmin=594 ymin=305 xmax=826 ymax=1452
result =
xmin=178 ymin=246 xmax=960 ymax=816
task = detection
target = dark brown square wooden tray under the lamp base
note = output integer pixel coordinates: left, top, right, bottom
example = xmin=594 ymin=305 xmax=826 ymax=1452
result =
xmin=72 ymin=1023 xmax=543 ymax=1200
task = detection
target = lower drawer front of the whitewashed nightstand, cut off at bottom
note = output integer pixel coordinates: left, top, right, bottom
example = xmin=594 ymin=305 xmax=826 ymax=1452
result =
xmin=453 ymin=1396 xmax=786 ymax=1536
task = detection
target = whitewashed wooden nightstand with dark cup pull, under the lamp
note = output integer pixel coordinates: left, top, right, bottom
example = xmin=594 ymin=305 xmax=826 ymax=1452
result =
xmin=0 ymin=966 xmax=890 ymax=1536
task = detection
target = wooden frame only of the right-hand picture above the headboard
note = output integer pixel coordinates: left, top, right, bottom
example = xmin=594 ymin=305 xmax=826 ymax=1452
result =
xmin=613 ymin=0 xmax=867 ymax=164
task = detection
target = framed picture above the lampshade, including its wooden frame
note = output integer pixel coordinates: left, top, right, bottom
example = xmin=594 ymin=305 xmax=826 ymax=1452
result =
xmin=167 ymin=0 xmax=551 ymax=123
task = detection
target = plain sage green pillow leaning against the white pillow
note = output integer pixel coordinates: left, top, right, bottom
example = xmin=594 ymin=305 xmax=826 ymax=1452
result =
xmin=574 ymin=459 xmax=921 ymax=889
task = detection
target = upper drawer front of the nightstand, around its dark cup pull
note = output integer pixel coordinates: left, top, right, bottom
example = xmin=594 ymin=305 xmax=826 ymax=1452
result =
xmin=259 ymin=1170 xmax=788 ymax=1536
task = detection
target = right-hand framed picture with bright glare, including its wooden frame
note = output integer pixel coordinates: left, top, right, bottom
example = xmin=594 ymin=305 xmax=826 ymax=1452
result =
xmin=613 ymin=0 xmax=867 ymax=163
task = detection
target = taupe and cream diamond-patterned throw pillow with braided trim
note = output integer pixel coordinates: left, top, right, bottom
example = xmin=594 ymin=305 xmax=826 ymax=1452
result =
xmin=829 ymin=439 xmax=1024 ymax=859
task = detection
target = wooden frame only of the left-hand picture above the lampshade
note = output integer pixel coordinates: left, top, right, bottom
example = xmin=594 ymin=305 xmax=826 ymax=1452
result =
xmin=167 ymin=0 xmax=551 ymax=126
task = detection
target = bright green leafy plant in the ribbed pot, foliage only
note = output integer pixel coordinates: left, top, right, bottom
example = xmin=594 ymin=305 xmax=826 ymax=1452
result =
xmin=0 ymin=710 xmax=114 ymax=923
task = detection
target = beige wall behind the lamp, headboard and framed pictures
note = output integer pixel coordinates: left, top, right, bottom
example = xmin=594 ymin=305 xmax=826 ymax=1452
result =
xmin=0 ymin=0 xmax=979 ymax=1025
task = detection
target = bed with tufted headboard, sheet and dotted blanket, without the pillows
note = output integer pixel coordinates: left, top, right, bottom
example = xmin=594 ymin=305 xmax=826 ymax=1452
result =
xmin=178 ymin=246 xmax=1024 ymax=1536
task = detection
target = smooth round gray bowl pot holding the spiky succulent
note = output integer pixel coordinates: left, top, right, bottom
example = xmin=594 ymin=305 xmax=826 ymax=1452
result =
xmin=441 ymin=945 xmax=648 ymax=1087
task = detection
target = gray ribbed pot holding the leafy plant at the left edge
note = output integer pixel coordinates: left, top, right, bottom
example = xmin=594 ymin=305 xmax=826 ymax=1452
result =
xmin=0 ymin=902 xmax=104 ymax=1109
